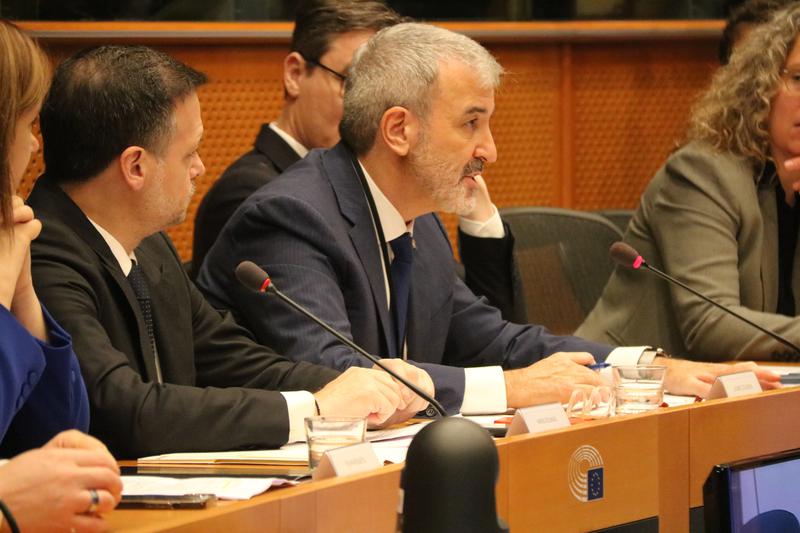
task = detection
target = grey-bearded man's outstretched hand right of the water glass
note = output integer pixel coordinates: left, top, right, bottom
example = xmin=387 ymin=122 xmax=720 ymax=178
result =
xmin=653 ymin=357 xmax=781 ymax=398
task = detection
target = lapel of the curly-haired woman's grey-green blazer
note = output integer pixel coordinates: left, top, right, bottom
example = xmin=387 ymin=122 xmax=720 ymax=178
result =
xmin=758 ymin=179 xmax=780 ymax=311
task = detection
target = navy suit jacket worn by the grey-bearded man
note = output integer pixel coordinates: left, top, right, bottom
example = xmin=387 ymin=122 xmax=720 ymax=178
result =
xmin=198 ymin=143 xmax=610 ymax=412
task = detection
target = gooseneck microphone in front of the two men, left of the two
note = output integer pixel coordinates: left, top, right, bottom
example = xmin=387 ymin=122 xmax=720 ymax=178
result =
xmin=236 ymin=261 xmax=447 ymax=417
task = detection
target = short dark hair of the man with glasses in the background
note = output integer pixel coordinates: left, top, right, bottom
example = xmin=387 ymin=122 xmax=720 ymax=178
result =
xmin=291 ymin=0 xmax=408 ymax=64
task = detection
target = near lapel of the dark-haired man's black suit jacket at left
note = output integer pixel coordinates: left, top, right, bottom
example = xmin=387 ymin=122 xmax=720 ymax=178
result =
xmin=31 ymin=175 xmax=161 ymax=382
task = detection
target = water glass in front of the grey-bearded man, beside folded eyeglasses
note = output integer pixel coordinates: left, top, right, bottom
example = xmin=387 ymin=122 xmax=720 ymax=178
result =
xmin=611 ymin=365 xmax=667 ymax=415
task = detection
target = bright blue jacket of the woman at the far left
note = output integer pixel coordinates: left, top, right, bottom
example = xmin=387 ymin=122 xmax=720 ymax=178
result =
xmin=0 ymin=306 xmax=89 ymax=457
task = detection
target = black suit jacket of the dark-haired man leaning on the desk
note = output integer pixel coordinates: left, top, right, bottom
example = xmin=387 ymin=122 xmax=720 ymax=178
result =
xmin=29 ymin=176 xmax=337 ymax=457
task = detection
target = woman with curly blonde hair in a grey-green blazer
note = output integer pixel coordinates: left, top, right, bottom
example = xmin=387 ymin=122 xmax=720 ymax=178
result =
xmin=576 ymin=4 xmax=800 ymax=361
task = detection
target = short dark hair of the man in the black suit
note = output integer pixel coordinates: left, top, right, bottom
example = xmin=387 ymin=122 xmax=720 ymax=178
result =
xmin=40 ymin=45 xmax=207 ymax=183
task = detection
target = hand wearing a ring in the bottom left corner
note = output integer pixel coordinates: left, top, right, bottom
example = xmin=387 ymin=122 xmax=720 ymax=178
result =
xmin=0 ymin=437 xmax=122 ymax=531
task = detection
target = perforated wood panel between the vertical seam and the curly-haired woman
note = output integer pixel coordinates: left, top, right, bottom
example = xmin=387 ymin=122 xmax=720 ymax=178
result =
xmin=572 ymin=42 xmax=715 ymax=209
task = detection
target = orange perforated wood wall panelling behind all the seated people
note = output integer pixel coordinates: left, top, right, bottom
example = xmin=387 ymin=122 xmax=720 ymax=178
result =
xmin=21 ymin=33 xmax=716 ymax=260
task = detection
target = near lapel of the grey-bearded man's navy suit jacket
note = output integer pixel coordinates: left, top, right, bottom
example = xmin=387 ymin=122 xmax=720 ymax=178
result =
xmin=321 ymin=142 xmax=397 ymax=357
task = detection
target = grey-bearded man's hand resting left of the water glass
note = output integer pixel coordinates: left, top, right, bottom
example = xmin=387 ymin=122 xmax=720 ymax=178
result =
xmin=504 ymin=352 xmax=605 ymax=408
